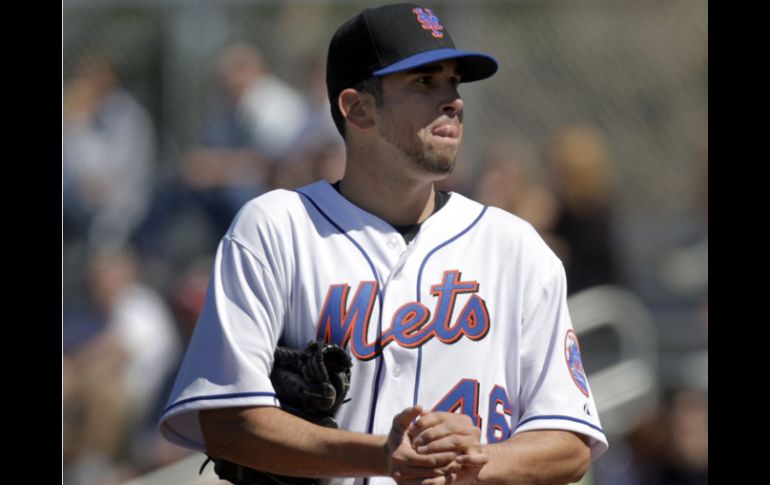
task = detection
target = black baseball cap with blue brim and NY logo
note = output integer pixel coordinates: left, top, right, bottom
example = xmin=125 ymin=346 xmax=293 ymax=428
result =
xmin=326 ymin=3 xmax=497 ymax=105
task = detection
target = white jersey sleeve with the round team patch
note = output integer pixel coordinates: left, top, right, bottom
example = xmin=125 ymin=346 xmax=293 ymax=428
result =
xmin=514 ymin=263 xmax=608 ymax=460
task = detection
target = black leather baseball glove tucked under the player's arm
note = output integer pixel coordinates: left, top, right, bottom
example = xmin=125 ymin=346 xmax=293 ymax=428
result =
xmin=200 ymin=341 xmax=353 ymax=485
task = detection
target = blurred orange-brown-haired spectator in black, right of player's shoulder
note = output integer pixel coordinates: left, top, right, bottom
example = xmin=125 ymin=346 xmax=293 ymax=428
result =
xmin=548 ymin=126 xmax=620 ymax=294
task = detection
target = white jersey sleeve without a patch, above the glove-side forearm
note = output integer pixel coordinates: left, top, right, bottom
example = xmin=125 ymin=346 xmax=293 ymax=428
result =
xmin=159 ymin=236 xmax=285 ymax=450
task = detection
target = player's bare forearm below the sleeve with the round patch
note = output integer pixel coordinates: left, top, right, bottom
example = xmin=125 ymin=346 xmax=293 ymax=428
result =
xmin=476 ymin=430 xmax=591 ymax=485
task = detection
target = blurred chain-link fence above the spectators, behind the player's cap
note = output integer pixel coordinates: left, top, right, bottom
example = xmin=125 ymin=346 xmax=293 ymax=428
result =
xmin=63 ymin=0 xmax=708 ymax=218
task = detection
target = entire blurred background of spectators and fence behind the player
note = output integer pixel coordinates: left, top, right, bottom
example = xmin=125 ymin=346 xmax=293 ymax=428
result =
xmin=62 ymin=0 xmax=708 ymax=485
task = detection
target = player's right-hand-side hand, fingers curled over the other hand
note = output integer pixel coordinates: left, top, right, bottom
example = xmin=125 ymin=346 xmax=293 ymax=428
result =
xmin=407 ymin=412 xmax=489 ymax=485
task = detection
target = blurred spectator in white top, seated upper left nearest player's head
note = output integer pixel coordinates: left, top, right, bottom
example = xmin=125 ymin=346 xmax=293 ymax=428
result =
xmin=182 ymin=41 xmax=310 ymax=193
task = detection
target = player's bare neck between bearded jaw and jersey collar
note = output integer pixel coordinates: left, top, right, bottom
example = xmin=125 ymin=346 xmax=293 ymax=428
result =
xmin=340 ymin=160 xmax=435 ymax=226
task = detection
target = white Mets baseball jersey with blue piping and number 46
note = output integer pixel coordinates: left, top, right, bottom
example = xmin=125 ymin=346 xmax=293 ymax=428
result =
xmin=160 ymin=182 xmax=607 ymax=484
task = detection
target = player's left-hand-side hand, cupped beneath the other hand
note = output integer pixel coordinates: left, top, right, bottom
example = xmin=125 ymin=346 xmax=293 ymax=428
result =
xmin=387 ymin=405 xmax=461 ymax=485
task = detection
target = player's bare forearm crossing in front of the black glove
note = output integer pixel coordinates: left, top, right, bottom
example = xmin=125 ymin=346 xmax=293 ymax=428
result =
xmin=200 ymin=407 xmax=388 ymax=478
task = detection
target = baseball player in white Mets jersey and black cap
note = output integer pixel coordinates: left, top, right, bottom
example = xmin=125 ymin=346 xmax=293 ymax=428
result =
xmin=160 ymin=4 xmax=607 ymax=484
